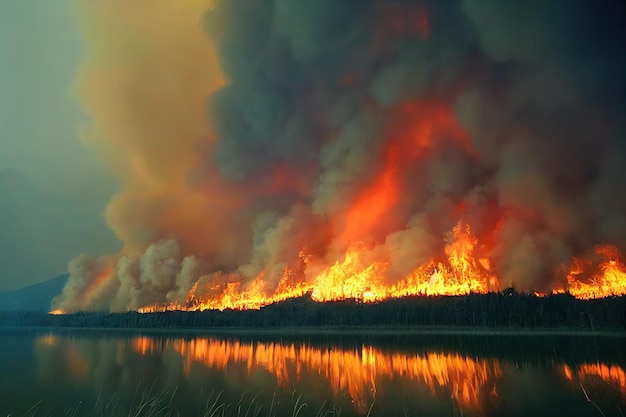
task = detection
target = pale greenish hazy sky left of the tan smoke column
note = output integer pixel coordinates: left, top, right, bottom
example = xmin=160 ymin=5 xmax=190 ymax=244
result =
xmin=0 ymin=1 xmax=117 ymax=291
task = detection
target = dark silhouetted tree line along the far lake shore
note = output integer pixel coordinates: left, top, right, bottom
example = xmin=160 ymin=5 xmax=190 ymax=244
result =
xmin=0 ymin=289 xmax=626 ymax=330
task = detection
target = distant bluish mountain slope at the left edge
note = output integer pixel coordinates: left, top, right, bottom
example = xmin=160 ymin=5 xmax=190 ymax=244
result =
xmin=0 ymin=274 xmax=68 ymax=311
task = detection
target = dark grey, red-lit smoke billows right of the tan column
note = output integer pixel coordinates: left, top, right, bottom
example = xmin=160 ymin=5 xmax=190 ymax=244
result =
xmin=54 ymin=0 xmax=626 ymax=310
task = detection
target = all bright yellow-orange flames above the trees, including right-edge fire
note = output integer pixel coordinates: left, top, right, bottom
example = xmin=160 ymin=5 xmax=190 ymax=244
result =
xmin=133 ymin=222 xmax=626 ymax=313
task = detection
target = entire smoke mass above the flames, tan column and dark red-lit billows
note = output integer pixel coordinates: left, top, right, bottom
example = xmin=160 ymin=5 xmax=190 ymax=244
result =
xmin=55 ymin=0 xmax=626 ymax=310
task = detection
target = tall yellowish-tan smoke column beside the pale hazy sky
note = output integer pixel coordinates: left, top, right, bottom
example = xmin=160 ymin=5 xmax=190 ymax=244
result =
xmin=55 ymin=0 xmax=229 ymax=309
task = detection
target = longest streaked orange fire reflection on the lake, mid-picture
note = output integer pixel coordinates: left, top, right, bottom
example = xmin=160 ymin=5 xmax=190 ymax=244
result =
xmin=158 ymin=338 xmax=502 ymax=412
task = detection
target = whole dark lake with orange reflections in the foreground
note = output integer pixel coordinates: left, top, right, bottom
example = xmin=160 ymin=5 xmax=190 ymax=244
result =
xmin=0 ymin=329 xmax=626 ymax=417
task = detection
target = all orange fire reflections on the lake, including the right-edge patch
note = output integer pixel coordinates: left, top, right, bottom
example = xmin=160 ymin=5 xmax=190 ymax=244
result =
xmin=37 ymin=335 xmax=626 ymax=415
